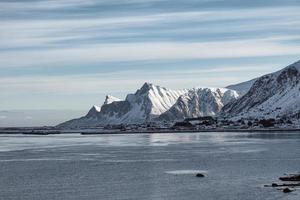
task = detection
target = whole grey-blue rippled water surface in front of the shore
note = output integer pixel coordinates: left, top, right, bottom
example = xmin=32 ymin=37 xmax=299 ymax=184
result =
xmin=0 ymin=133 xmax=300 ymax=200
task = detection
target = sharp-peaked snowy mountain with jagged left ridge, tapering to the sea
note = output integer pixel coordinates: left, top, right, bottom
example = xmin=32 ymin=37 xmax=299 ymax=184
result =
xmin=60 ymin=83 xmax=187 ymax=127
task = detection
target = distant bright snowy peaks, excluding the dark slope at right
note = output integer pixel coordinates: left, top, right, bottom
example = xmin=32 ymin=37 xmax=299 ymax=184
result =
xmin=60 ymin=83 xmax=239 ymax=127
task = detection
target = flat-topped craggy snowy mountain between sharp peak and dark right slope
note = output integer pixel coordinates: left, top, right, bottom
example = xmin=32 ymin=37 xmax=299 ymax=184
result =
xmin=159 ymin=88 xmax=239 ymax=121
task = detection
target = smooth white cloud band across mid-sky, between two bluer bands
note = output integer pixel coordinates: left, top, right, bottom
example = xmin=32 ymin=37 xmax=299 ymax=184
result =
xmin=0 ymin=40 xmax=300 ymax=67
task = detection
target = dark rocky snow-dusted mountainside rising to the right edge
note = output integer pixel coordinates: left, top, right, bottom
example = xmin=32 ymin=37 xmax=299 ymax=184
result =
xmin=222 ymin=61 xmax=300 ymax=118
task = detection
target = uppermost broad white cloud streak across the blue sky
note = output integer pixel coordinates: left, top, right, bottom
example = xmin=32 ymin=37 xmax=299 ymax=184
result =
xmin=0 ymin=7 xmax=300 ymax=48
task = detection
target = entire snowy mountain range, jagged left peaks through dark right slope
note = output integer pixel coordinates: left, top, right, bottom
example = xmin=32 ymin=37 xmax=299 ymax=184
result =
xmin=60 ymin=61 xmax=300 ymax=127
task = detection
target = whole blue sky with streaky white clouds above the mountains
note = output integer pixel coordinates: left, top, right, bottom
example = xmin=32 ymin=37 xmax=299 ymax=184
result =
xmin=0 ymin=0 xmax=300 ymax=126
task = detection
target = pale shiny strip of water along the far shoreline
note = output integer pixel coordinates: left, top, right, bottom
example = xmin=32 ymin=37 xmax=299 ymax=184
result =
xmin=0 ymin=132 xmax=300 ymax=151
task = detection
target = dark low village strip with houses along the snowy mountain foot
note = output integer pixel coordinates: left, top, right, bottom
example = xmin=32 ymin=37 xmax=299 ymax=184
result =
xmin=98 ymin=116 xmax=300 ymax=132
